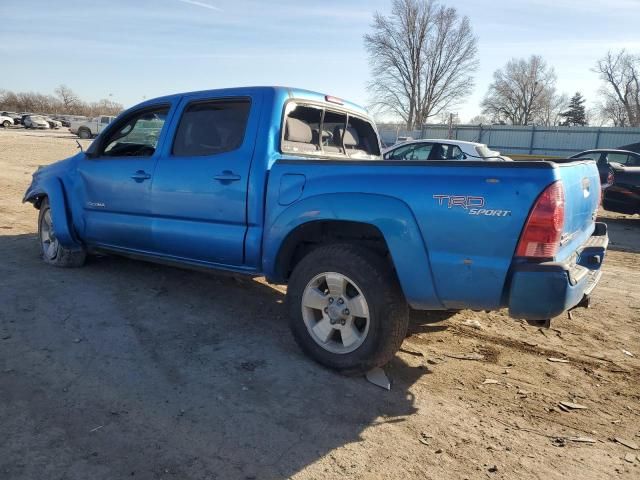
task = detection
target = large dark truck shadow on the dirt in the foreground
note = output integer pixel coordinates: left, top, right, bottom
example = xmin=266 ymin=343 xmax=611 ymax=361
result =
xmin=0 ymin=235 xmax=435 ymax=480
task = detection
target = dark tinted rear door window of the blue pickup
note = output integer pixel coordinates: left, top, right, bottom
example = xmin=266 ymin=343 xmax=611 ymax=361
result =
xmin=173 ymin=100 xmax=251 ymax=157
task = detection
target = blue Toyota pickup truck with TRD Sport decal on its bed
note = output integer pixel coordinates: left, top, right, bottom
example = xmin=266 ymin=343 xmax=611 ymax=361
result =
xmin=24 ymin=87 xmax=608 ymax=373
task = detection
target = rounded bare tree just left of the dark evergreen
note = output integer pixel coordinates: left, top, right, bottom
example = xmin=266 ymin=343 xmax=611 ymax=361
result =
xmin=482 ymin=55 xmax=556 ymax=125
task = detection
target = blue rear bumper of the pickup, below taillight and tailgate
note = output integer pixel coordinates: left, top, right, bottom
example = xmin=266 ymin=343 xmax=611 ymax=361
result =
xmin=508 ymin=223 xmax=609 ymax=320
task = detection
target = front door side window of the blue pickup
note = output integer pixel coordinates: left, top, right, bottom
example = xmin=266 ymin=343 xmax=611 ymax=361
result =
xmin=99 ymin=106 xmax=169 ymax=157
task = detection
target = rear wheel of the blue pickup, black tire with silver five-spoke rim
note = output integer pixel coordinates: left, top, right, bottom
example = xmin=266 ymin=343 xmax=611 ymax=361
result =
xmin=287 ymin=244 xmax=409 ymax=375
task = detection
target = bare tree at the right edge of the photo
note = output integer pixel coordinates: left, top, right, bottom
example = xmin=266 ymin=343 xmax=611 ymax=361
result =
xmin=595 ymin=50 xmax=640 ymax=127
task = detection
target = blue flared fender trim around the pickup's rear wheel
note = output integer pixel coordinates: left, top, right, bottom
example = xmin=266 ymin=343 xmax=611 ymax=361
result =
xmin=262 ymin=193 xmax=444 ymax=310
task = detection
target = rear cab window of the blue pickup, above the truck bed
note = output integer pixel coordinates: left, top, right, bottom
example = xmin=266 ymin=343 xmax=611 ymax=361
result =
xmin=282 ymin=103 xmax=380 ymax=159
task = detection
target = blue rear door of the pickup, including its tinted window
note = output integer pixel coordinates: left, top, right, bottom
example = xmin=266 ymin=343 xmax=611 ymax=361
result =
xmin=151 ymin=93 xmax=262 ymax=267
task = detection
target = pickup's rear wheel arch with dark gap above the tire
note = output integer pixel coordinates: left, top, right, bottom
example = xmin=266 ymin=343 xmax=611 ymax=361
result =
xmin=263 ymin=193 xmax=444 ymax=309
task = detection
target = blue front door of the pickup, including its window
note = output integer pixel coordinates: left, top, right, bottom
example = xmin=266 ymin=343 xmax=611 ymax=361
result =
xmin=78 ymin=105 xmax=170 ymax=252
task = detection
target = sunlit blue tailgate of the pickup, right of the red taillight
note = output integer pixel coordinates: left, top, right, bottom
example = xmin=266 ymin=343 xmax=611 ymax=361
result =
xmin=556 ymin=161 xmax=600 ymax=261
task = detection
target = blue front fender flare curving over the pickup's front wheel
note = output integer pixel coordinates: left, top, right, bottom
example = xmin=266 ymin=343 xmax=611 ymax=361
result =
xmin=22 ymin=176 xmax=82 ymax=248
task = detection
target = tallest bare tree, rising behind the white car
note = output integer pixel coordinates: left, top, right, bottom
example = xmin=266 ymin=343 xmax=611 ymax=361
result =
xmin=364 ymin=0 xmax=478 ymax=129
